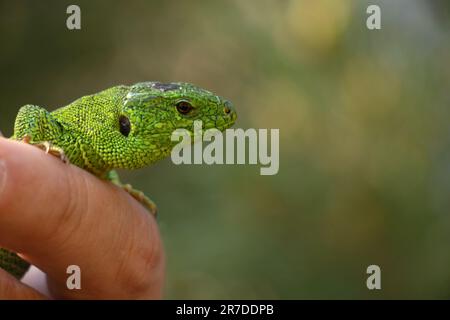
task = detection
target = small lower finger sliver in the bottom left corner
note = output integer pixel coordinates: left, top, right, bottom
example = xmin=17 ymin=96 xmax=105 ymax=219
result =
xmin=0 ymin=269 xmax=46 ymax=300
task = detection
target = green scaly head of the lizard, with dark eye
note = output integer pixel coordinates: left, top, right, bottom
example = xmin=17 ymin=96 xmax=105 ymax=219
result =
xmin=119 ymin=82 xmax=237 ymax=166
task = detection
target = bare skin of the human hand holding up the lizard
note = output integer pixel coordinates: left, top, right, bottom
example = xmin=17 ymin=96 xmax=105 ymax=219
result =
xmin=0 ymin=138 xmax=165 ymax=299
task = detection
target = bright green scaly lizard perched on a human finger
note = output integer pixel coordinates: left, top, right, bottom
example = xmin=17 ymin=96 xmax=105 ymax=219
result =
xmin=0 ymin=82 xmax=236 ymax=278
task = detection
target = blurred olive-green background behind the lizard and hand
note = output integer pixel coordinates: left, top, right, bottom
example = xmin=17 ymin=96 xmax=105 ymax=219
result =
xmin=0 ymin=0 xmax=450 ymax=299
